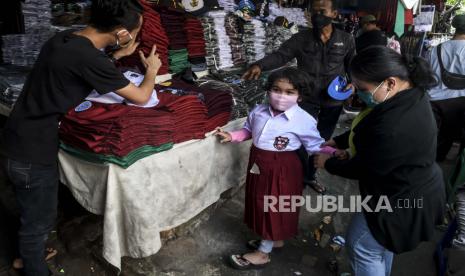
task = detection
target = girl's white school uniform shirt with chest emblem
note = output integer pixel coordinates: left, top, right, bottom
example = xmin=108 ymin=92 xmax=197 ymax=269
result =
xmin=244 ymin=104 xmax=325 ymax=154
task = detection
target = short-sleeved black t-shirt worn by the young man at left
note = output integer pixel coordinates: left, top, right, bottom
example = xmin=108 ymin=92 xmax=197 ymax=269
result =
xmin=2 ymin=30 xmax=129 ymax=164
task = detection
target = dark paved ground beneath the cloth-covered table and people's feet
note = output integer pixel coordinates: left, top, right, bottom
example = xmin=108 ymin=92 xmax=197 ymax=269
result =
xmin=0 ymin=117 xmax=452 ymax=276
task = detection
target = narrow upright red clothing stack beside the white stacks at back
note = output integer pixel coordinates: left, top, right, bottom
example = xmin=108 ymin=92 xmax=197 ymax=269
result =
xmin=184 ymin=18 xmax=207 ymax=58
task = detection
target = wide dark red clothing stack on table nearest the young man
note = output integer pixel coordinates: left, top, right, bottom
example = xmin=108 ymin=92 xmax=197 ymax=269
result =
xmin=60 ymin=103 xmax=175 ymax=157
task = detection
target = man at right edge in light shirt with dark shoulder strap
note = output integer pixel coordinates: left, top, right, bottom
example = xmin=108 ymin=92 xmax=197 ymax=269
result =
xmin=429 ymin=15 xmax=465 ymax=161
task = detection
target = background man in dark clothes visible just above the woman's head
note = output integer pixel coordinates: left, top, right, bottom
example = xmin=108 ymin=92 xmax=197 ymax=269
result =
xmin=355 ymin=14 xmax=387 ymax=53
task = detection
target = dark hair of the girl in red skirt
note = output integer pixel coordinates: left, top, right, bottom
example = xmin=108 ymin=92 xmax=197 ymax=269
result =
xmin=265 ymin=67 xmax=312 ymax=98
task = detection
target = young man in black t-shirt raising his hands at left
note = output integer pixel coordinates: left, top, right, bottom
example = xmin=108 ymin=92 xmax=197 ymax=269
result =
xmin=2 ymin=0 xmax=161 ymax=276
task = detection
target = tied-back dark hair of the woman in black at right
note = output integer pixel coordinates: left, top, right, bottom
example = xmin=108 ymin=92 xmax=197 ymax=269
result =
xmin=349 ymin=46 xmax=438 ymax=90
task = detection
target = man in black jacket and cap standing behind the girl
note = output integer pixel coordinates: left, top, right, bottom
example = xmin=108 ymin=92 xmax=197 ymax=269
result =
xmin=243 ymin=0 xmax=355 ymax=192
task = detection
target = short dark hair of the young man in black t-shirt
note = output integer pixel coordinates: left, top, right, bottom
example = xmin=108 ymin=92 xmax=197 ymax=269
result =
xmin=89 ymin=0 xmax=143 ymax=33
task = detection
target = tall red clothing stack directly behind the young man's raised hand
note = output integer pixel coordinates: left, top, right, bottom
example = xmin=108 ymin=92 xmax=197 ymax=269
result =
xmin=119 ymin=0 xmax=169 ymax=75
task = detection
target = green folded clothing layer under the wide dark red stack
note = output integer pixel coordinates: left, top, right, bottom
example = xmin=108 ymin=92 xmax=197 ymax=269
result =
xmin=60 ymin=143 xmax=173 ymax=169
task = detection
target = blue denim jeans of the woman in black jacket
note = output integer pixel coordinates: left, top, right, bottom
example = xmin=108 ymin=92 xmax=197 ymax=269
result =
xmin=346 ymin=213 xmax=394 ymax=276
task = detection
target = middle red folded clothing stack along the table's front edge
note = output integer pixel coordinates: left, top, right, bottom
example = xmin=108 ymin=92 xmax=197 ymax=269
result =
xmin=157 ymin=90 xmax=208 ymax=143
